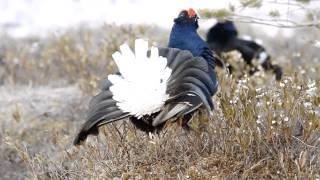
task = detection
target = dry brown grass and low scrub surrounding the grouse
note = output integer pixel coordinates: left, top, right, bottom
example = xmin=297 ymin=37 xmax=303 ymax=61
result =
xmin=0 ymin=26 xmax=320 ymax=179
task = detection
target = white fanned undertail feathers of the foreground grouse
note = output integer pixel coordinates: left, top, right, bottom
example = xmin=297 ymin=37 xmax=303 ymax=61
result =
xmin=108 ymin=39 xmax=172 ymax=118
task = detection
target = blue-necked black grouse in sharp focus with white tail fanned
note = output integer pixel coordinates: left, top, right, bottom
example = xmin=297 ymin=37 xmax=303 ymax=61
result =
xmin=74 ymin=9 xmax=218 ymax=145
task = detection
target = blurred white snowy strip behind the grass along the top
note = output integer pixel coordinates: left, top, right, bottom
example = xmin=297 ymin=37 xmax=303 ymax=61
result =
xmin=0 ymin=0 xmax=320 ymax=37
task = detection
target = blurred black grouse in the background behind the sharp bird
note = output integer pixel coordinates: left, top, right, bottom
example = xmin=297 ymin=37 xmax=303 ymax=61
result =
xmin=207 ymin=21 xmax=282 ymax=80
